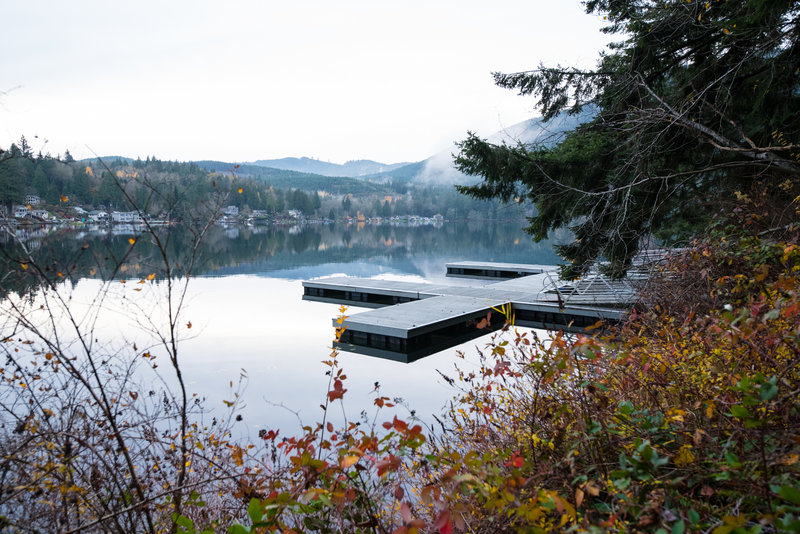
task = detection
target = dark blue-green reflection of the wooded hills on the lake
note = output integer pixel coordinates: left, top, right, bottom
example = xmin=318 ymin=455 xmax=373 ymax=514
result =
xmin=0 ymin=221 xmax=559 ymax=292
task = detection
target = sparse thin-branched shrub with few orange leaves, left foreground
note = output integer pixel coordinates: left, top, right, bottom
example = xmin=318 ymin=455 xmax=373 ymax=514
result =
xmin=0 ymin=169 xmax=258 ymax=533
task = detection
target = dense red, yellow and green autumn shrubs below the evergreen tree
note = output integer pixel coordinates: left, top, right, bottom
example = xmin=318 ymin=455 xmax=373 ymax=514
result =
xmin=406 ymin=217 xmax=800 ymax=534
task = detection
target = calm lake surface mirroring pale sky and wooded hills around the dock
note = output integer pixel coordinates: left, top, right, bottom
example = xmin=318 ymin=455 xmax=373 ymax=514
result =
xmin=0 ymin=221 xmax=566 ymax=435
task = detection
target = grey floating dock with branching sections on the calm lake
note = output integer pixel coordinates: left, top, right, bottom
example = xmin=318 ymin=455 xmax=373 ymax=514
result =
xmin=303 ymin=256 xmax=663 ymax=362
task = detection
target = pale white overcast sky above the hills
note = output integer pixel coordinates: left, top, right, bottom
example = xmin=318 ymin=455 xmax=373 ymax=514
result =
xmin=0 ymin=0 xmax=609 ymax=163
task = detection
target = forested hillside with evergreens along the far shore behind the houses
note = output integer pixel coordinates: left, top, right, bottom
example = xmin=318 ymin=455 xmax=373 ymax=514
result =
xmin=0 ymin=137 xmax=523 ymax=220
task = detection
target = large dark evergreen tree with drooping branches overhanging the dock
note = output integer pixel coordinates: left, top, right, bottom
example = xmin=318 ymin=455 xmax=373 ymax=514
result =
xmin=457 ymin=0 xmax=800 ymax=276
